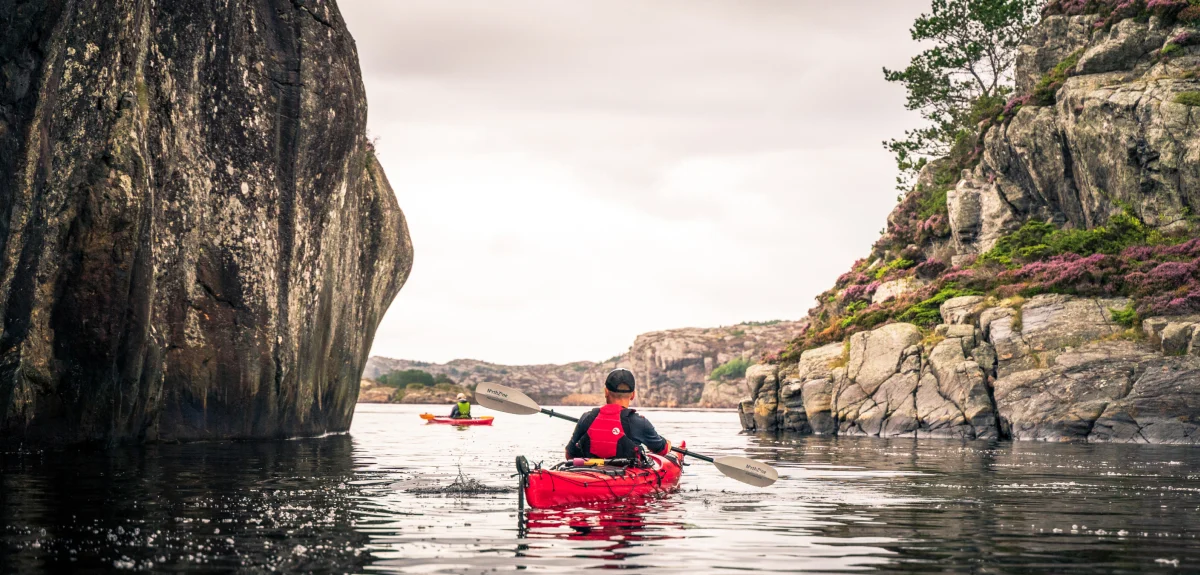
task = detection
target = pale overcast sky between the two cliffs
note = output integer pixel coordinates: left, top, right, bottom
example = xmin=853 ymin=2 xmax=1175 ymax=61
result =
xmin=340 ymin=0 xmax=929 ymax=364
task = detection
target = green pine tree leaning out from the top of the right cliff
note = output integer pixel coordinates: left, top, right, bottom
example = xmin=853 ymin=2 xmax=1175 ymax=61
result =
xmin=883 ymin=0 xmax=1044 ymax=192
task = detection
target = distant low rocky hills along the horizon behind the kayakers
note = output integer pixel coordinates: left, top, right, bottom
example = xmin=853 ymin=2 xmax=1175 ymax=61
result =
xmin=362 ymin=322 xmax=805 ymax=407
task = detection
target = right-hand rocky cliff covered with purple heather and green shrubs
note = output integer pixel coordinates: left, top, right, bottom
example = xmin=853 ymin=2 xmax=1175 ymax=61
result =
xmin=739 ymin=1 xmax=1200 ymax=444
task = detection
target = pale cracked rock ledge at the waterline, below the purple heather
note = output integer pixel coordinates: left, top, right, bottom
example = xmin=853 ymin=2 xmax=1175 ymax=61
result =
xmin=739 ymin=295 xmax=1200 ymax=443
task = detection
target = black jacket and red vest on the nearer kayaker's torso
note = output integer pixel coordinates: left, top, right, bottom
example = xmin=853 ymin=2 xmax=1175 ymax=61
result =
xmin=566 ymin=405 xmax=667 ymax=459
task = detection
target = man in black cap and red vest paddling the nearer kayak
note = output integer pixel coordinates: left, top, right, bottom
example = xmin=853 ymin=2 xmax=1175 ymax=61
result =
xmin=566 ymin=369 xmax=671 ymax=460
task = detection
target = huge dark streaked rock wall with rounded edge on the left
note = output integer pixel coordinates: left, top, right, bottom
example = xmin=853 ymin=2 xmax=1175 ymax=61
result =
xmin=0 ymin=0 xmax=412 ymax=443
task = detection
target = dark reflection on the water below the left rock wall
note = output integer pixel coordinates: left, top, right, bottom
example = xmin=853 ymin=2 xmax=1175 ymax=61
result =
xmin=0 ymin=436 xmax=368 ymax=573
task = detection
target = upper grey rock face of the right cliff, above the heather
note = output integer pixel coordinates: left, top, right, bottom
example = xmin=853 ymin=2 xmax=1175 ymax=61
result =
xmin=948 ymin=16 xmax=1200 ymax=257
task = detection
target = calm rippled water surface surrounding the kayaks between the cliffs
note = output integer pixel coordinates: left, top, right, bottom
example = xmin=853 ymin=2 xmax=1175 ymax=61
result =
xmin=0 ymin=405 xmax=1200 ymax=574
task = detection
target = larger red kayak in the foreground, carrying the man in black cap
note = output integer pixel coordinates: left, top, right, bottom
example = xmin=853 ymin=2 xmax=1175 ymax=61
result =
xmin=517 ymin=455 xmax=683 ymax=509
